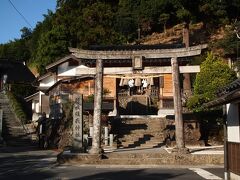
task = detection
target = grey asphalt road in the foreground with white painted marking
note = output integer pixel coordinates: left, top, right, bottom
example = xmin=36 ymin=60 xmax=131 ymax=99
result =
xmin=0 ymin=148 xmax=223 ymax=180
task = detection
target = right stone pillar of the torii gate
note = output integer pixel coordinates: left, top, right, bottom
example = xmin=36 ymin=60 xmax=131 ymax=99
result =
xmin=171 ymin=57 xmax=185 ymax=149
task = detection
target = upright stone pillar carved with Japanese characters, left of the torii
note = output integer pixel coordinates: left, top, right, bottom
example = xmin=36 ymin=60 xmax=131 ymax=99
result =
xmin=73 ymin=94 xmax=84 ymax=152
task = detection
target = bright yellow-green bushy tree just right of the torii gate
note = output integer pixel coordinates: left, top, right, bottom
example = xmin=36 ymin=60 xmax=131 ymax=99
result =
xmin=187 ymin=52 xmax=236 ymax=111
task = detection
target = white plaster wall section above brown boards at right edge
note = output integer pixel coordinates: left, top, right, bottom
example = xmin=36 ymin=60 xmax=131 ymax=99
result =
xmin=227 ymin=104 xmax=240 ymax=142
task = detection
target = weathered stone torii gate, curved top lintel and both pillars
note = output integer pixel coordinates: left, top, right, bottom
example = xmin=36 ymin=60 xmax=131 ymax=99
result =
xmin=69 ymin=44 xmax=207 ymax=154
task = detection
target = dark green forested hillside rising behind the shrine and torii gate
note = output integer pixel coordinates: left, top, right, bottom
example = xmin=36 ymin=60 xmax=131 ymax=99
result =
xmin=0 ymin=0 xmax=240 ymax=74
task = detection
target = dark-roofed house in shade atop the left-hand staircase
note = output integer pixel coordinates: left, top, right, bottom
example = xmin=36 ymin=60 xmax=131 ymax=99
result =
xmin=0 ymin=59 xmax=35 ymax=91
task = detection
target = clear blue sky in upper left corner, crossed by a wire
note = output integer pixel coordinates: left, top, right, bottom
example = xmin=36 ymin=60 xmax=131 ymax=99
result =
xmin=0 ymin=0 xmax=56 ymax=44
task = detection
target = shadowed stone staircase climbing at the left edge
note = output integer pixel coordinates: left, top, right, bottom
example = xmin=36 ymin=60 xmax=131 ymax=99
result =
xmin=0 ymin=93 xmax=33 ymax=147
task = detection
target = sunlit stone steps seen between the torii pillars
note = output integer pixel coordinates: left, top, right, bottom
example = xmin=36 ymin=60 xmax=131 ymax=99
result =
xmin=118 ymin=118 xmax=165 ymax=148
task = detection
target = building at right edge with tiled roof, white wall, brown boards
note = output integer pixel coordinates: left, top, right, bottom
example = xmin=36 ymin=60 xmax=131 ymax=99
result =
xmin=205 ymin=79 xmax=240 ymax=179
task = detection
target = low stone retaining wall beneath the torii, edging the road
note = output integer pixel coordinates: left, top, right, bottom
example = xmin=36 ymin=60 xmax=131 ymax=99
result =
xmin=58 ymin=153 xmax=224 ymax=166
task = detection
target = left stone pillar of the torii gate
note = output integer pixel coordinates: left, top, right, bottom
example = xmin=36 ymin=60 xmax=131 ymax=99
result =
xmin=89 ymin=59 xmax=103 ymax=154
